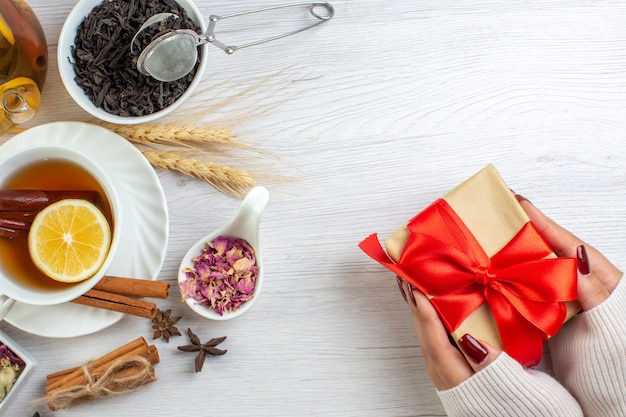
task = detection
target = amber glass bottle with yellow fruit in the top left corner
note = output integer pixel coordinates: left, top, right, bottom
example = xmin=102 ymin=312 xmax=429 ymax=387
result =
xmin=0 ymin=0 xmax=48 ymax=135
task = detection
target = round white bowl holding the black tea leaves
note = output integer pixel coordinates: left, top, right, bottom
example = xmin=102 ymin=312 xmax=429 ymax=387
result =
xmin=57 ymin=0 xmax=208 ymax=124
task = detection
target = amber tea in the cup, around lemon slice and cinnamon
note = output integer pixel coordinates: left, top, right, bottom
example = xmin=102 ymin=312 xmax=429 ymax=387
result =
xmin=0 ymin=159 xmax=113 ymax=291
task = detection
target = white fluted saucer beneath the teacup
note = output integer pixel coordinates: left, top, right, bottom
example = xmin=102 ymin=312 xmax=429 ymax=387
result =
xmin=0 ymin=122 xmax=169 ymax=337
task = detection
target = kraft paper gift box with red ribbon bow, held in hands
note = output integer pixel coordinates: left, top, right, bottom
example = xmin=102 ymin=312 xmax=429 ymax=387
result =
xmin=359 ymin=165 xmax=579 ymax=366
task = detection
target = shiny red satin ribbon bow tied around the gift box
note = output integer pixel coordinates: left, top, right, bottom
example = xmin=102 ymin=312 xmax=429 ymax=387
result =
xmin=359 ymin=200 xmax=577 ymax=366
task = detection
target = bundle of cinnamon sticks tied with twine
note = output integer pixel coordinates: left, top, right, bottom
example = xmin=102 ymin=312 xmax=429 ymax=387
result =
xmin=42 ymin=337 xmax=160 ymax=411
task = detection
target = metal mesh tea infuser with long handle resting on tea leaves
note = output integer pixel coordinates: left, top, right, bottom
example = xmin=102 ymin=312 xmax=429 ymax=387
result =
xmin=131 ymin=2 xmax=335 ymax=82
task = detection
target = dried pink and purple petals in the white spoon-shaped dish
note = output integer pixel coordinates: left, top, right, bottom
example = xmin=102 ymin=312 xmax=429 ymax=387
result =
xmin=181 ymin=236 xmax=259 ymax=315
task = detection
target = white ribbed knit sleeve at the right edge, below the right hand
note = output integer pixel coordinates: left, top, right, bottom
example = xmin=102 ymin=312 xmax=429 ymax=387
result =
xmin=550 ymin=279 xmax=626 ymax=417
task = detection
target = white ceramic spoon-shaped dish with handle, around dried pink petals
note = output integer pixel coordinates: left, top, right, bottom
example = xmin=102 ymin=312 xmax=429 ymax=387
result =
xmin=178 ymin=187 xmax=269 ymax=320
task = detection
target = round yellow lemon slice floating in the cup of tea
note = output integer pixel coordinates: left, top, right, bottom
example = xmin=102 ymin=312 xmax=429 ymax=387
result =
xmin=28 ymin=199 xmax=111 ymax=283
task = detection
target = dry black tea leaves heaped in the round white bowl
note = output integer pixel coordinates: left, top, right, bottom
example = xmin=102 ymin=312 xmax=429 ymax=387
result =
xmin=72 ymin=0 xmax=200 ymax=117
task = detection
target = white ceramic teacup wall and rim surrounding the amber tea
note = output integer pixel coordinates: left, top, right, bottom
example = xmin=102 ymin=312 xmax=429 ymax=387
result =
xmin=0 ymin=143 xmax=124 ymax=306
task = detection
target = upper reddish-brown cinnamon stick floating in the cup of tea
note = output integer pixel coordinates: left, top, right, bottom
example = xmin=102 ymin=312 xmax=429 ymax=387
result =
xmin=0 ymin=190 xmax=99 ymax=212
